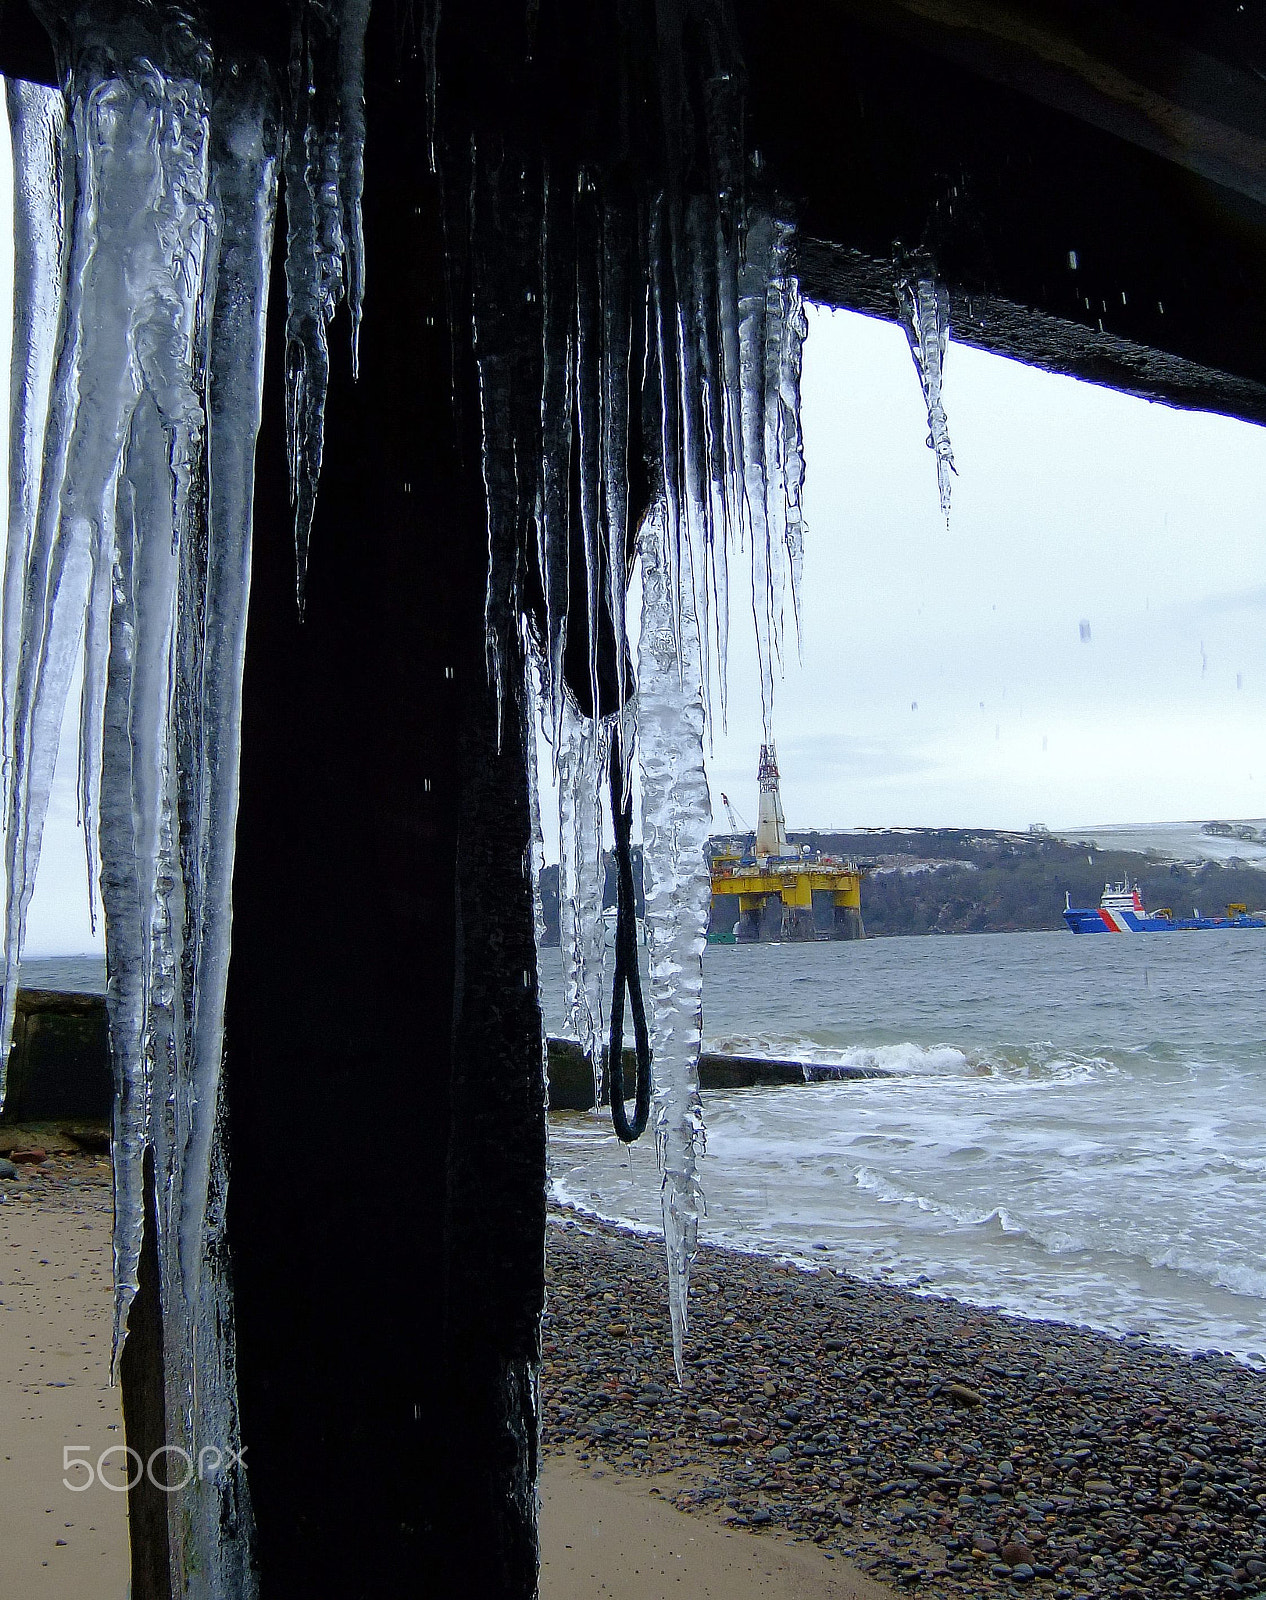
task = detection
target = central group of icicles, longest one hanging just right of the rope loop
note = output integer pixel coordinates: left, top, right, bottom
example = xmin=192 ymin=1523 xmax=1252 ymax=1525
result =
xmin=471 ymin=187 xmax=807 ymax=1362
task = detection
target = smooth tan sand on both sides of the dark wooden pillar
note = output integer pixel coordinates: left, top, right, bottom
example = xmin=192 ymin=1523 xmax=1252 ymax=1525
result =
xmin=0 ymin=1141 xmax=887 ymax=1600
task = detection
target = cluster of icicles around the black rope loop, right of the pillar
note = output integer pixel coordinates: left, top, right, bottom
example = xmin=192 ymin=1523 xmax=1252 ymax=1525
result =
xmin=524 ymin=203 xmax=807 ymax=1373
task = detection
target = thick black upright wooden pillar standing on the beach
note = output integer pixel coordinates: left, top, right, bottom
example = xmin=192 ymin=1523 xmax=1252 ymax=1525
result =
xmin=226 ymin=18 xmax=544 ymax=1600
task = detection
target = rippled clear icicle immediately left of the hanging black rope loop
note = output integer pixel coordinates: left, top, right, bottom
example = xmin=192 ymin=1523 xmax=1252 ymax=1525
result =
xmin=555 ymin=699 xmax=610 ymax=1106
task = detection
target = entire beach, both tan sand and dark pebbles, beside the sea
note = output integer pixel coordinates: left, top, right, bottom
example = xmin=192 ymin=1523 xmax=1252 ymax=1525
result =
xmin=0 ymin=1155 xmax=1266 ymax=1600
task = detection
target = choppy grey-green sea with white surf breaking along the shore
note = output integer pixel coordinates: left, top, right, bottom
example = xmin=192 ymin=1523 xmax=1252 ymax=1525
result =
xmin=546 ymin=931 xmax=1266 ymax=1355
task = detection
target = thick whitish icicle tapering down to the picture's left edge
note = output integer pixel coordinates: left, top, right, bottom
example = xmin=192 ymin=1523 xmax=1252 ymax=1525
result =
xmin=3 ymin=66 xmax=208 ymax=1100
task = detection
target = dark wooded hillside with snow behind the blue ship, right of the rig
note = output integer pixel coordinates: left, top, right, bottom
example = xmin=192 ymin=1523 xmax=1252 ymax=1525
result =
xmin=789 ymin=827 xmax=1266 ymax=938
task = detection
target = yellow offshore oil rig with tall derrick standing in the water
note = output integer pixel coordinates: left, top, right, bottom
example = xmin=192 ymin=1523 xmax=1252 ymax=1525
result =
xmin=707 ymin=744 xmax=869 ymax=944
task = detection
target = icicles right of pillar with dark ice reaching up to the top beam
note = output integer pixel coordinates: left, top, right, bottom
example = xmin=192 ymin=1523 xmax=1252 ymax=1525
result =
xmin=460 ymin=0 xmax=807 ymax=1362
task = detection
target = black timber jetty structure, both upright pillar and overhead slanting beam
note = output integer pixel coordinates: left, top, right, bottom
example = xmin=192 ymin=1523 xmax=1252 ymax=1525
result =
xmin=0 ymin=0 xmax=1266 ymax=1600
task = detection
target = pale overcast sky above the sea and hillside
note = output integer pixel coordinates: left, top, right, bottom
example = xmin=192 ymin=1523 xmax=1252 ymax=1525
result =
xmin=9 ymin=299 xmax=1266 ymax=954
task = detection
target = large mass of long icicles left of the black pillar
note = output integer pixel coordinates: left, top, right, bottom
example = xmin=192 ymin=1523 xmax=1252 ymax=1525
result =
xmin=0 ymin=3 xmax=368 ymax=1574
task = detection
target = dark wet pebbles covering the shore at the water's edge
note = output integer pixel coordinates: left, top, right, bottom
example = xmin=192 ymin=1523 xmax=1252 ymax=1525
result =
xmin=541 ymin=1210 xmax=1266 ymax=1600
